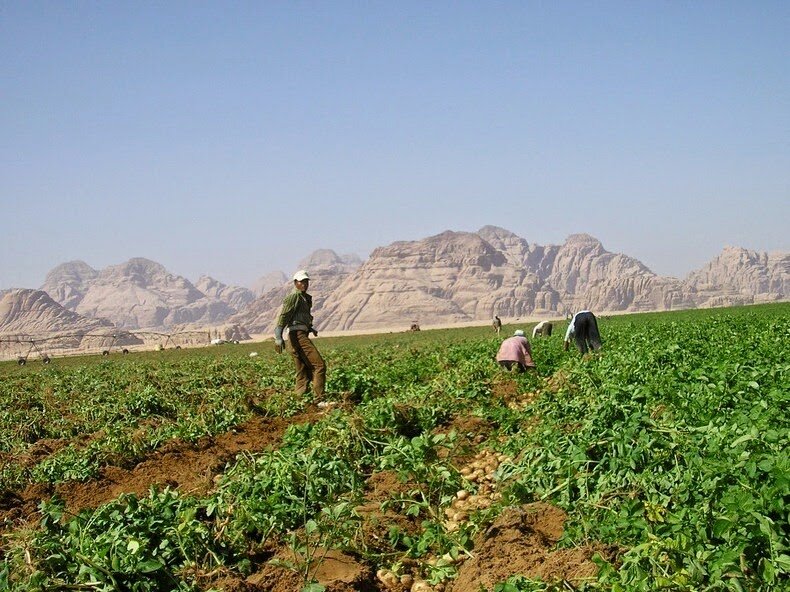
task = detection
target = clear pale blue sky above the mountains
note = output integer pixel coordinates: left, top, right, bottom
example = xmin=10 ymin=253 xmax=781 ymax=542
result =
xmin=0 ymin=0 xmax=790 ymax=289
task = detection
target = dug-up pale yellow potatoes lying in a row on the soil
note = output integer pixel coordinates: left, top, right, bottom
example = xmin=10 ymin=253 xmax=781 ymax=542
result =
xmin=376 ymin=450 xmax=512 ymax=592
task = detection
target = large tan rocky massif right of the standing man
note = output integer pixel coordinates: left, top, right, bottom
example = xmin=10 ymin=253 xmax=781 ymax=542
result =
xmin=310 ymin=226 xmax=790 ymax=330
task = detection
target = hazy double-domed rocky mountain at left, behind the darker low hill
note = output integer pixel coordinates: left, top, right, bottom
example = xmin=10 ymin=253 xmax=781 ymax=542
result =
xmin=42 ymin=257 xmax=254 ymax=330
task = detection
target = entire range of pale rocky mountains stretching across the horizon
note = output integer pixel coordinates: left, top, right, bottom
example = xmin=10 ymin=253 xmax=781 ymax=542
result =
xmin=0 ymin=226 xmax=790 ymax=333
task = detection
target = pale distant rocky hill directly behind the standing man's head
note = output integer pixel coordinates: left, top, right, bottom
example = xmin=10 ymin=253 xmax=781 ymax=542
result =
xmin=230 ymin=249 xmax=362 ymax=333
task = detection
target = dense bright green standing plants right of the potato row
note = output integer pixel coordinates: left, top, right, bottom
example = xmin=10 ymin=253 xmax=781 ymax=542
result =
xmin=508 ymin=314 xmax=790 ymax=590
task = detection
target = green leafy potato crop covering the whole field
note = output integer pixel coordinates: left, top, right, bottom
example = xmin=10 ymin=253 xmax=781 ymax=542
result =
xmin=0 ymin=304 xmax=790 ymax=592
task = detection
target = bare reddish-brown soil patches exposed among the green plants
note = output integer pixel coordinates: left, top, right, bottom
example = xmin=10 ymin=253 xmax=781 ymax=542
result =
xmin=0 ymin=402 xmax=612 ymax=592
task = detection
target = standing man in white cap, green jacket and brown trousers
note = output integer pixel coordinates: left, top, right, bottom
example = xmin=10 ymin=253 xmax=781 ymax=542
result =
xmin=274 ymin=269 xmax=326 ymax=397
